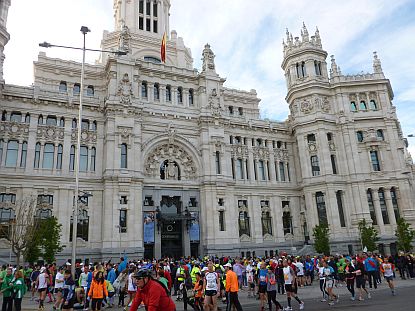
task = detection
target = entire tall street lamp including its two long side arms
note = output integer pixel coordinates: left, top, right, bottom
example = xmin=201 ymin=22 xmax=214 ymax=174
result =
xmin=39 ymin=26 xmax=127 ymax=275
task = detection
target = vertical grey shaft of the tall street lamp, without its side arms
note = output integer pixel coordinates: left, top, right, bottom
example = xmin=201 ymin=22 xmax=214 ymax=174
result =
xmin=71 ymin=26 xmax=90 ymax=277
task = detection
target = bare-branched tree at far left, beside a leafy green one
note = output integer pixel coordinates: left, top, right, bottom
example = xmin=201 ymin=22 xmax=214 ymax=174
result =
xmin=5 ymin=196 xmax=38 ymax=266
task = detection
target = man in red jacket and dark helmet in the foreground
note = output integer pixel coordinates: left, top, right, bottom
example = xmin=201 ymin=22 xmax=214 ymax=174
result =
xmin=130 ymin=269 xmax=176 ymax=311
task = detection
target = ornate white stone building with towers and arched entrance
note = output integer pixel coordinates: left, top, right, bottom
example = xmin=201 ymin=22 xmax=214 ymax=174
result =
xmin=0 ymin=0 xmax=415 ymax=259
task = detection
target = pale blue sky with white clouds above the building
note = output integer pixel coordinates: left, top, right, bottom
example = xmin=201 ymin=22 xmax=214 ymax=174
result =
xmin=4 ymin=0 xmax=415 ymax=157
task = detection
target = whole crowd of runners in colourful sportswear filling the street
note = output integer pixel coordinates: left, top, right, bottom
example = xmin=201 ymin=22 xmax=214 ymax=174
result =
xmin=0 ymin=253 xmax=415 ymax=311
